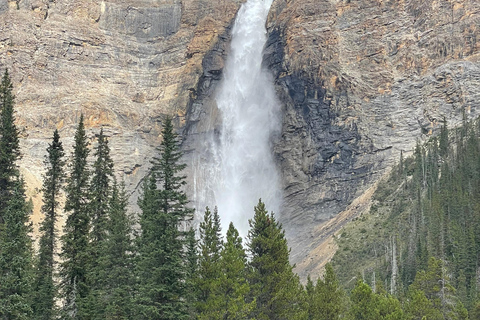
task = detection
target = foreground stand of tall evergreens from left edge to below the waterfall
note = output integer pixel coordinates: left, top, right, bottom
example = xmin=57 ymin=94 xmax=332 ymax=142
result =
xmin=0 ymin=72 xmax=308 ymax=320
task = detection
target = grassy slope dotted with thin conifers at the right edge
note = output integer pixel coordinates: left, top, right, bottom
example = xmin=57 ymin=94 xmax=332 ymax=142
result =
xmin=333 ymin=113 xmax=480 ymax=319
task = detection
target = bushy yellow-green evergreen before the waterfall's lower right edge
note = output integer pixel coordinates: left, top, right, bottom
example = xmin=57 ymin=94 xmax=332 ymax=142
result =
xmin=248 ymin=200 xmax=307 ymax=320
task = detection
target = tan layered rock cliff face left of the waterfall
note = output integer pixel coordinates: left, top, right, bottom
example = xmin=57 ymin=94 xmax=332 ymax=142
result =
xmin=0 ymin=0 xmax=241 ymax=230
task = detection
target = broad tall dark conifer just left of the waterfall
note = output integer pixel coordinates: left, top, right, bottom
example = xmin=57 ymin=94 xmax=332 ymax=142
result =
xmin=137 ymin=117 xmax=193 ymax=320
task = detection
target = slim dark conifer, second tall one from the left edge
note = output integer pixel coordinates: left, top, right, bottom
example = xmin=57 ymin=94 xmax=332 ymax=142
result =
xmin=33 ymin=130 xmax=65 ymax=320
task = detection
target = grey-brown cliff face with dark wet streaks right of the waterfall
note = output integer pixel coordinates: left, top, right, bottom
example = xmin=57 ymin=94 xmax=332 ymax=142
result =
xmin=265 ymin=0 xmax=480 ymax=274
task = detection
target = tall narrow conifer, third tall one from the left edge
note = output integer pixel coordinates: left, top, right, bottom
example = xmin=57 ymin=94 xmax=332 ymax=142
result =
xmin=61 ymin=115 xmax=91 ymax=319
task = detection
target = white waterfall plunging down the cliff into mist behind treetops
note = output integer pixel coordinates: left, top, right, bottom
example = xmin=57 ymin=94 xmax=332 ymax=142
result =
xmin=194 ymin=0 xmax=282 ymax=237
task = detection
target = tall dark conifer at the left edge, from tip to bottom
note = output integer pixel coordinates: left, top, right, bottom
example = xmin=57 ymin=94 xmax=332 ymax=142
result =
xmin=0 ymin=71 xmax=33 ymax=319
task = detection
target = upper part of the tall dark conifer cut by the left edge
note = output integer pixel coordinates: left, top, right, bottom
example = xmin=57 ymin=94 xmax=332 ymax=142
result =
xmin=0 ymin=70 xmax=20 ymax=224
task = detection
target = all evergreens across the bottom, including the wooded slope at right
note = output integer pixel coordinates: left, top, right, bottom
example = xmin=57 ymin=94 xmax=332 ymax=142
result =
xmin=0 ymin=72 xmax=480 ymax=320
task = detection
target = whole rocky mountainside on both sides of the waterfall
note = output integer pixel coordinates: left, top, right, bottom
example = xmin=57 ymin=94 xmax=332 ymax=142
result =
xmin=0 ymin=0 xmax=480 ymax=275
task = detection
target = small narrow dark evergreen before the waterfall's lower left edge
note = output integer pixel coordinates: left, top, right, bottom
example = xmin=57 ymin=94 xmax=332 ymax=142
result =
xmin=196 ymin=207 xmax=222 ymax=318
